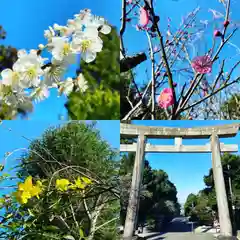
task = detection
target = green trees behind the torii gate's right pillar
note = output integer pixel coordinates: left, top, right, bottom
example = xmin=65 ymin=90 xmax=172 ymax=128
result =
xmin=184 ymin=153 xmax=240 ymax=228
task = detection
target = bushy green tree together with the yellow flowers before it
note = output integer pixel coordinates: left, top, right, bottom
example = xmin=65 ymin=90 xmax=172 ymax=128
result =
xmin=0 ymin=122 xmax=119 ymax=240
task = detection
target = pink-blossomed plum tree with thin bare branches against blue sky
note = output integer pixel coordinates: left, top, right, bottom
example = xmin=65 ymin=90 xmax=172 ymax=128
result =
xmin=120 ymin=0 xmax=240 ymax=120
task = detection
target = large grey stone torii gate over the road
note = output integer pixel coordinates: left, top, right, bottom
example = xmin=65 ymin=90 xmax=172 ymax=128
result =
xmin=120 ymin=123 xmax=240 ymax=240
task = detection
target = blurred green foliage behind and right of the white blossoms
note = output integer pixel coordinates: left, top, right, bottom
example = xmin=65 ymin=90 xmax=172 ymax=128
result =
xmin=65 ymin=28 xmax=121 ymax=120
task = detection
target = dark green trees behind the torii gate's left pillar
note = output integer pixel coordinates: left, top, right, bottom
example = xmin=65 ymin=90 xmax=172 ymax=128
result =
xmin=120 ymin=154 xmax=180 ymax=228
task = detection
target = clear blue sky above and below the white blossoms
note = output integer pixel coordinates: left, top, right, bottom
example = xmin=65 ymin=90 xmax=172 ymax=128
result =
xmin=0 ymin=0 xmax=121 ymax=121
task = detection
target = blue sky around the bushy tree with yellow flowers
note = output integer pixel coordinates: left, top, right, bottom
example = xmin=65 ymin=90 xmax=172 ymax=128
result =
xmin=0 ymin=120 xmax=120 ymax=195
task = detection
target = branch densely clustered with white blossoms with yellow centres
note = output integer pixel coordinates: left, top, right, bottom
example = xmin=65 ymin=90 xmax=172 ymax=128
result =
xmin=0 ymin=9 xmax=119 ymax=119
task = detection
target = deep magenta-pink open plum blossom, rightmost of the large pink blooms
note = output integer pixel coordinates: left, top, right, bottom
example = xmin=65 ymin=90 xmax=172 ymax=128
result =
xmin=192 ymin=55 xmax=212 ymax=74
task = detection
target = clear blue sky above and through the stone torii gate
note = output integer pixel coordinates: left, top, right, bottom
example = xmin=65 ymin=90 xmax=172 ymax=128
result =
xmin=133 ymin=120 xmax=240 ymax=203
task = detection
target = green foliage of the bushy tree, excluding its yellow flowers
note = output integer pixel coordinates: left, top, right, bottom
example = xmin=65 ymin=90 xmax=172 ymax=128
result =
xmin=1 ymin=122 xmax=120 ymax=240
